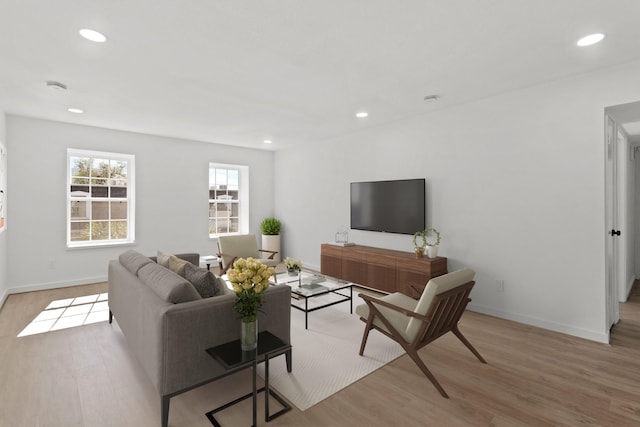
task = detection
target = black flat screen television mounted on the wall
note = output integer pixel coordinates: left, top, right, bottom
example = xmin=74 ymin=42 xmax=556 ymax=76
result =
xmin=351 ymin=178 xmax=425 ymax=234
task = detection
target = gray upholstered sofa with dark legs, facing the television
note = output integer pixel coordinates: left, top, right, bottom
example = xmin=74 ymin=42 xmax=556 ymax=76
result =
xmin=108 ymin=250 xmax=291 ymax=427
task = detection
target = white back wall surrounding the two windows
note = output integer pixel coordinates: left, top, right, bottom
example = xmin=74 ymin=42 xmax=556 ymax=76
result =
xmin=6 ymin=115 xmax=274 ymax=292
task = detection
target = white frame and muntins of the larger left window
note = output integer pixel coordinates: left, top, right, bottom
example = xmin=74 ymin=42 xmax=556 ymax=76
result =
xmin=66 ymin=148 xmax=135 ymax=249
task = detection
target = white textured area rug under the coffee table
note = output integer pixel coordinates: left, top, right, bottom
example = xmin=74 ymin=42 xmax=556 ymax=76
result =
xmin=258 ymin=298 xmax=404 ymax=411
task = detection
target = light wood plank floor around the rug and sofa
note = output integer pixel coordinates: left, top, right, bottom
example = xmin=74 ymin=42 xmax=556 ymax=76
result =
xmin=0 ymin=284 xmax=640 ymax=427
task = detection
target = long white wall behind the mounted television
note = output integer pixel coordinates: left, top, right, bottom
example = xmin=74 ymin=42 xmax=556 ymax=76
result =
xmin=275 ymin=58 xmax=640 ymax=342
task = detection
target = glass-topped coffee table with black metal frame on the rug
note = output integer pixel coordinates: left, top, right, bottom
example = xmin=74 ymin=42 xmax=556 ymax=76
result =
xmin=272 ymin=269 xmax=353 ymax=329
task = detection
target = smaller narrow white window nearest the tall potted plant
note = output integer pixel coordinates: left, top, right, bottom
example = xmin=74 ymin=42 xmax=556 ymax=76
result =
xmin=209 ymin=163 xmax=249 ymax=237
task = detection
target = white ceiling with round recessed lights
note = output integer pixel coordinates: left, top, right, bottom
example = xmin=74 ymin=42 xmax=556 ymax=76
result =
xmin=0 ymin=0 xmax=640 ymax=150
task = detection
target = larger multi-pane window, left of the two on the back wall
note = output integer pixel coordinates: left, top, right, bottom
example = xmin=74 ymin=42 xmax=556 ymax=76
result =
xmin=67 ymin=149 xmax=135 ymax=247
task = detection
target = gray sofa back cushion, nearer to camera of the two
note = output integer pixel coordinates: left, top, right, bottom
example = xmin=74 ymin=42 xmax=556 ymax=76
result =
xmin=138 ymin=262 xmax=202 ymax=304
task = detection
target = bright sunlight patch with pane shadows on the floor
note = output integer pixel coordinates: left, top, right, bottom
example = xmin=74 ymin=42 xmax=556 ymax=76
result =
xmin=18 ymin=293 xmax=109 ymax=337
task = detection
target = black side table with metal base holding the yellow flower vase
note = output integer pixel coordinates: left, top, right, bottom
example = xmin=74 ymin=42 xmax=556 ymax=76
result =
xmin=206 ymin=331 xmax=291 ymax=427
